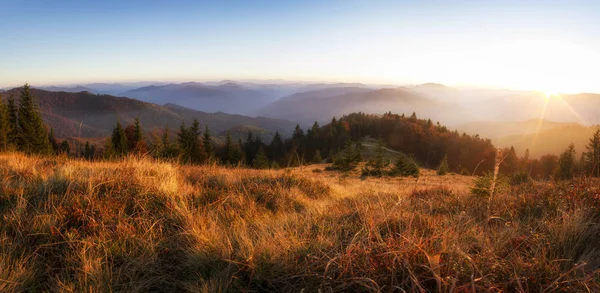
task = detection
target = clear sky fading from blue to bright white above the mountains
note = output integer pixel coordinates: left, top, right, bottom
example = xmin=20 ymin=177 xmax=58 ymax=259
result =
xmin=0 ymin=0 xmax=600 ymax=93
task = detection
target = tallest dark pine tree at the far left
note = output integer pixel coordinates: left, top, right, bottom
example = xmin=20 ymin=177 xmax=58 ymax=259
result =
xmin=18 ymin=84 xmax=51 ymax=154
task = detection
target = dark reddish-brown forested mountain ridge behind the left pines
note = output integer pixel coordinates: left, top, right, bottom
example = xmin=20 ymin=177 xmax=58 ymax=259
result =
xmin=2 ymin=88 xmax=295 ymax=137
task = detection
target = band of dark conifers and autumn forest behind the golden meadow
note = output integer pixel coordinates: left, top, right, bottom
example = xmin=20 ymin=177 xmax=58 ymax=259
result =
xmin=0 ymin=84 xmax=600 ymax=179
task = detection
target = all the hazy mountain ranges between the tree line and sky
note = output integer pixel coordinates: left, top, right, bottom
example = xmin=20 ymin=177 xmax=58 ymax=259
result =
xmin=3 ymin=80 xmax=600 ymax=155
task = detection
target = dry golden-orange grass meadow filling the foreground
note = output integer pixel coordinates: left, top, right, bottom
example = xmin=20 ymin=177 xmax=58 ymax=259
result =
xmin=0 ymin=153 xmax=600 ymax=292
